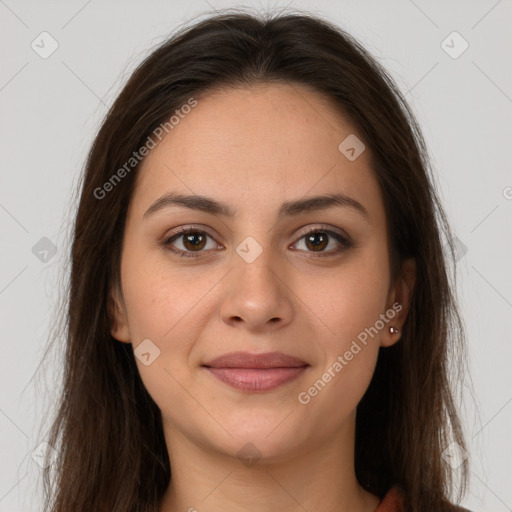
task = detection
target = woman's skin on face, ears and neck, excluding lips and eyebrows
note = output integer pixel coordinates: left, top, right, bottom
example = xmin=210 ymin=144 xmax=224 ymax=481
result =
xmin=111 ymin=84 xmax=414 ymax=512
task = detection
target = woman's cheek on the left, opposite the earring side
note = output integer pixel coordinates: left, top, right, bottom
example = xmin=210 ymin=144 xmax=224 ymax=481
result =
xmin=122 ymin=252 xmax=219 ymax=412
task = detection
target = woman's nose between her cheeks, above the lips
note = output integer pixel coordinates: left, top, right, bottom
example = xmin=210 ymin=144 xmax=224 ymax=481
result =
xmin=220 ymin=244 xmax=294 ymax=332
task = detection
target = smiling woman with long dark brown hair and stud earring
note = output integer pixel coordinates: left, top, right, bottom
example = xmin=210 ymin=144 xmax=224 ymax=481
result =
xmin=40 ymin=8 xmax=467 ymax=512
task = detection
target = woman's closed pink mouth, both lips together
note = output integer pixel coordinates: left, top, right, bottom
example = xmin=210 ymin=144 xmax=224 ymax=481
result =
xmin=202 ymin=352 xmax=309 ymax=392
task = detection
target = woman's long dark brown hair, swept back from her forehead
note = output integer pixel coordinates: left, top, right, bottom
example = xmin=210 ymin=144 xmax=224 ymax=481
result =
xmin=40 ymin=6 xmax=468 ymax=512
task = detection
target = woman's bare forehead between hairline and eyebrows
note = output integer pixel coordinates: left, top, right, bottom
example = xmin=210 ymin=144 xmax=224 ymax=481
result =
xmin=128 ymin=84 xmax=382 ymax=222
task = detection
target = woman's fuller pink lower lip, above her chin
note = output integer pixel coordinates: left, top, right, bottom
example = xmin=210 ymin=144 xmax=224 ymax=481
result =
xmin=206 ymin=366 xmax=307 ymax=392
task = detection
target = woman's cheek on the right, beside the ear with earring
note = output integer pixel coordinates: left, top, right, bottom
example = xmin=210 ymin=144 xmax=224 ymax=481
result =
xmin=292 ymin=244 xmax=389 ymax=414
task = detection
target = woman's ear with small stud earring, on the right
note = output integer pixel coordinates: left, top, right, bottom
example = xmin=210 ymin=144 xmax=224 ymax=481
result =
xmin=380 ymin=258 xmax=416 ymax=347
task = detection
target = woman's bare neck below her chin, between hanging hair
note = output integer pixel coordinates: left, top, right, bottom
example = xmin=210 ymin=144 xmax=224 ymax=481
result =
xmin=160 ymin=417 xmax=379 ymax=512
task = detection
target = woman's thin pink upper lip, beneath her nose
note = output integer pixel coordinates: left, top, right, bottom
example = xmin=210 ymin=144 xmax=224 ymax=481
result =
xmin=203 ymin=352 xmax=307 ymax=368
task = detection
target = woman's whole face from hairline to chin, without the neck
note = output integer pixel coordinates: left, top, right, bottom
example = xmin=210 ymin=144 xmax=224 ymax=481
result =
xmin=111 ymin=85 xmax=414 ymax=460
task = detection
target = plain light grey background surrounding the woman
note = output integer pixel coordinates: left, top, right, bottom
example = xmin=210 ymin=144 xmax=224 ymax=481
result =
xmin=0 ymin=0 xmax=512 ymax=512
